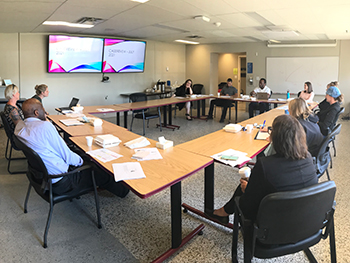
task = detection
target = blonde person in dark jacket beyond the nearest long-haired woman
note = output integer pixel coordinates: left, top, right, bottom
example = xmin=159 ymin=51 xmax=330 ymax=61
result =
xmin=288 ymin=98 xmax=324 ymax=157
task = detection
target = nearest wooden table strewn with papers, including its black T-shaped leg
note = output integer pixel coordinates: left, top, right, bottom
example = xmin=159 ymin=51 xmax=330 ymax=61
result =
xmin=71 ymin=130 xmax=213 ymax=262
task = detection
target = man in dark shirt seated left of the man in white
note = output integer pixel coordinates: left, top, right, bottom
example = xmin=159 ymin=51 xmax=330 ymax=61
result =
xmin=208 ymin=78 xmax=238 ymax=122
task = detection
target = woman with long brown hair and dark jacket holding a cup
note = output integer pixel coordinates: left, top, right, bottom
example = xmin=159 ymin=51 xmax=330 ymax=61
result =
xmin=206 ymin=115 xmax=318 ymax=223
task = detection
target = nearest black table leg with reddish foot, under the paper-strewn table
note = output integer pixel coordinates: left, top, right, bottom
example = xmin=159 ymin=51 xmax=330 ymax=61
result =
xmin=152 ymin=181 xmax=204 ymax=263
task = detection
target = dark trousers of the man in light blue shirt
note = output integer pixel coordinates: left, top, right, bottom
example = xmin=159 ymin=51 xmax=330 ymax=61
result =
xmin=52 ymin=159 xmax=129 ymax=197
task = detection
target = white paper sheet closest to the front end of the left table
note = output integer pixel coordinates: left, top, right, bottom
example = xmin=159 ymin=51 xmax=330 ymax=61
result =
xmin=112 ymin=162 xmax=146 ymax=182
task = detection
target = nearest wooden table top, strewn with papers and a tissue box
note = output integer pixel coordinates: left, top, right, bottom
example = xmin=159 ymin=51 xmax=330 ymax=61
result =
xmin=71 ymin=130 xmax=213 ymax=198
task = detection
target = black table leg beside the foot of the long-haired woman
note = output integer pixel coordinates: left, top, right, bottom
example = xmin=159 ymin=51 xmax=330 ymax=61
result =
xmin=182 ymin=163 xmax=233 ymax=228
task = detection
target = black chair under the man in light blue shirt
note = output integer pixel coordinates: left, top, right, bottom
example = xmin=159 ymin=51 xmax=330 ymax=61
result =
xmin=13 ymin=135 xmax=102 ymax=248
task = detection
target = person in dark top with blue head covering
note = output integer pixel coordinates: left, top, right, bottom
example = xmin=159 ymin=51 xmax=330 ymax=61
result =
xmin=317 ymin=86 xmax=344 ymax=136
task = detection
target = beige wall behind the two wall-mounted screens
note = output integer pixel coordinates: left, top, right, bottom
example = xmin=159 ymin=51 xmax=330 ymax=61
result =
xmin=0 ymin=34 xmax=186 ymax=114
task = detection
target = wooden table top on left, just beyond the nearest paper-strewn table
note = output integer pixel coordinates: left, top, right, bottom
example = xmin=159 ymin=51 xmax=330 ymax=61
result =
xmin=47 ymin=115 xmax=126 ymax=136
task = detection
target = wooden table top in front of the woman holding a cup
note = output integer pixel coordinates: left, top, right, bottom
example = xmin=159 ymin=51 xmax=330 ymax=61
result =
xmin=175 ymin=108 xmax=284 ymax=161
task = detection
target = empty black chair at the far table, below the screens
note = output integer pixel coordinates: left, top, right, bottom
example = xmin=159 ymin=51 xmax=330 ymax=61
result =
xmin=129 ymin=92 xmax=162 ymax=135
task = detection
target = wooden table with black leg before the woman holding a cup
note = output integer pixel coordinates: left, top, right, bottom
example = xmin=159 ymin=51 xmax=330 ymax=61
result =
xmin=175 ymin=108 xmax=285 ymax=227
